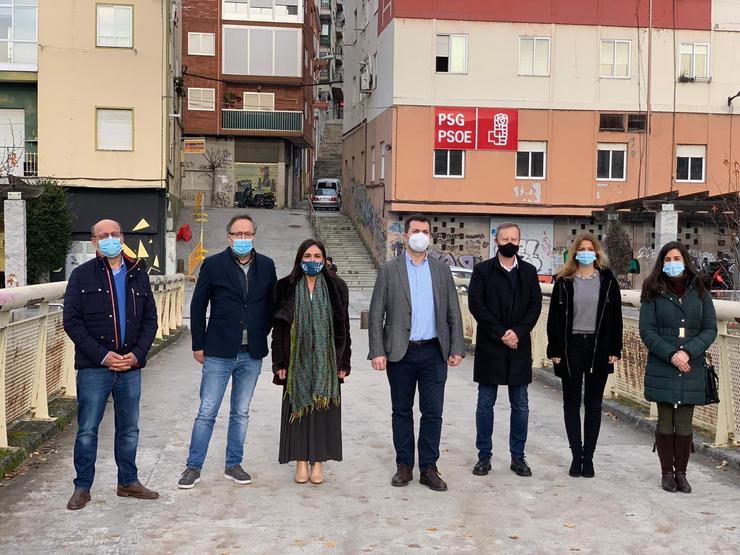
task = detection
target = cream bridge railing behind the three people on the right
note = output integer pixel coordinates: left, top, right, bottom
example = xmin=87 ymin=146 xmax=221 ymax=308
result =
xmin=459 ymin=284 xmax=740 ymax=445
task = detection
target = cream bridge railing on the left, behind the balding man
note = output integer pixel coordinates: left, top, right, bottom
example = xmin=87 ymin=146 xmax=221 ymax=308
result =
xmin=0 ymin=274 xmax=185 ymax=448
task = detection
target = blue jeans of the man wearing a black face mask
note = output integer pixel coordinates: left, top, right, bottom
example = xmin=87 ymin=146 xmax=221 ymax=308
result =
xmin=475 ymin=384 xmax=529 ymax=458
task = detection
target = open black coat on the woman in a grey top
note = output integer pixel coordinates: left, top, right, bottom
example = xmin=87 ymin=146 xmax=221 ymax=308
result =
xmin=547 ymin=268 xmax=622 ymax=378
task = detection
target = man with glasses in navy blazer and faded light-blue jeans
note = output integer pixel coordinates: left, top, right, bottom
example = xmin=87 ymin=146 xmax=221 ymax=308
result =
xmin=177 ymin=215 xmax=277 ymax=489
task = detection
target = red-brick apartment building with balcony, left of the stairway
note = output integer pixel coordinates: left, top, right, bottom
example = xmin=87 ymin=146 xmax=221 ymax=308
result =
xmin=182 ymin=0 xmax=326 ymax=207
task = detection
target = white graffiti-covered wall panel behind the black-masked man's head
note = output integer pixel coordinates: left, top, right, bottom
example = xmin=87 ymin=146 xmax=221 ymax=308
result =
xmin=490 ymin=217 xmax=557 ymax=276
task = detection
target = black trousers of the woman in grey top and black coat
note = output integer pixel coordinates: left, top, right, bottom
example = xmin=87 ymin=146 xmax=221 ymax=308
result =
xmin=563 ymin=334 xmax=608 ymax=460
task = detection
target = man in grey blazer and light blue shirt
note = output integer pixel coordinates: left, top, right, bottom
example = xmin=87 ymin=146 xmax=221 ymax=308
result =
xmin=368 ymin=214 xmax=465 ymax=491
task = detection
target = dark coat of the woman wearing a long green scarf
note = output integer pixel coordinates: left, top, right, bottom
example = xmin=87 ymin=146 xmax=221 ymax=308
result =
xmin=271 ymin=267 xmax=352 ymax=385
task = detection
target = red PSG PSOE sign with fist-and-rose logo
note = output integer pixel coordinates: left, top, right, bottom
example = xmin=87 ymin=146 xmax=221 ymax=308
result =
xmin=434 ymin=108 xmax=519 ymax=150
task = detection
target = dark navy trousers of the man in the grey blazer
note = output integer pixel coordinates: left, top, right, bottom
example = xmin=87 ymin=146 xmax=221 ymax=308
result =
xmin=386 ymin=342 xmax=447 ymax=470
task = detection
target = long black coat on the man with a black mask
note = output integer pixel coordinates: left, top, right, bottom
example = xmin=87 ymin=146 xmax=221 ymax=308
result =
xmin=468 ymin=257 xmax=542 ymax=385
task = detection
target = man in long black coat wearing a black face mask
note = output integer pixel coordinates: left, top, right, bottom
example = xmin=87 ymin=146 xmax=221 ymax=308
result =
xmin=468 ymin=223 xmax=542 ymax=476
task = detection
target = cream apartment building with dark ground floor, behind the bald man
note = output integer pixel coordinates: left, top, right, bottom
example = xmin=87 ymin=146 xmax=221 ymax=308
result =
xmin=35 ymin=0 xmax=181 ymax=275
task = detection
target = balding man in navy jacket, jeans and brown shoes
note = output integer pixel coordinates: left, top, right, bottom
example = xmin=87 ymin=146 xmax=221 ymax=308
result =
xmin=64 ymin=220 xmax=159 ymax=510
